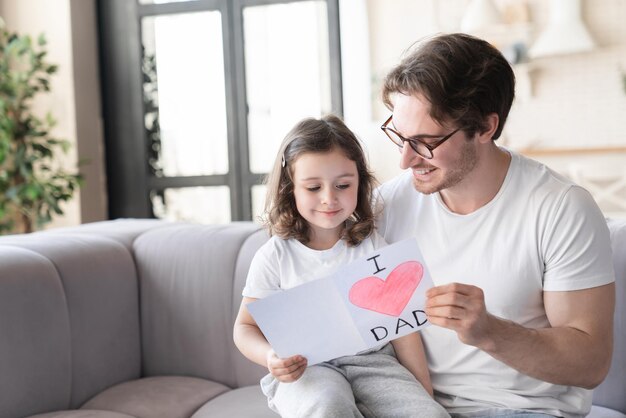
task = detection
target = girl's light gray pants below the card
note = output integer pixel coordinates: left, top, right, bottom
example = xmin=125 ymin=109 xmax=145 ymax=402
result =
xmin=261 ymin=344 xmax=450 ymax=418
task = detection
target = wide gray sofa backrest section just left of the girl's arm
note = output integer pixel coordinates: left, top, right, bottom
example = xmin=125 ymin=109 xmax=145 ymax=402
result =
xmin=133 ymin=223 xmax=259 ymax=387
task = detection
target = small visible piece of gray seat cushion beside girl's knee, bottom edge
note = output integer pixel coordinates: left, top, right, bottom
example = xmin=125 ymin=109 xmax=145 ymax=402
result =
xmin=191 ymin=385 xmax=279 ymax=418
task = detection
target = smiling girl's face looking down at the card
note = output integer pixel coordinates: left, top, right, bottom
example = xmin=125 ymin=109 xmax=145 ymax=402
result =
xmin=293 ymin=150 xmax=359 ymax=249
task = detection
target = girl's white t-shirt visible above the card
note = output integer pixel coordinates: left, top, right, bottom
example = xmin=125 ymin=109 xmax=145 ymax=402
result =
xmin=242 ymin=232 xmax=387 ymax=299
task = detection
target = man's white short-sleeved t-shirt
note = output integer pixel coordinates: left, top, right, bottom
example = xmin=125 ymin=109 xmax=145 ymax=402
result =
xmin=378 ymin=152 xmax=614 ymax=417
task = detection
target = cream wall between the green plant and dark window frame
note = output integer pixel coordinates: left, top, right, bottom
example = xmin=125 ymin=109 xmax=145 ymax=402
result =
xmin=0 ymin=0 xmax=106 ymax=228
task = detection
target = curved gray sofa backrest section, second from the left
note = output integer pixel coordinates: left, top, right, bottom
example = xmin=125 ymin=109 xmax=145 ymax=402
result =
xmin=3 ymin=232 xmax=141 ymax=410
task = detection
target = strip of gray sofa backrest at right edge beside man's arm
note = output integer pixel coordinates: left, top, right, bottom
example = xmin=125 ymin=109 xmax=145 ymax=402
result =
xmin=593 ymin=219 xmax=626 ymax=414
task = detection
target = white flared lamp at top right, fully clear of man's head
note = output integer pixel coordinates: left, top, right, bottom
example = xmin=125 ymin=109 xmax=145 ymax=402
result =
xmin=528 ymin=0 xmax=595 ymax=58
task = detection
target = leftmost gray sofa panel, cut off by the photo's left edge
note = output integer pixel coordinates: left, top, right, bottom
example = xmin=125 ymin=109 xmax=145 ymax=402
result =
xmin=0 ymin=248 xmax=72 ymax=418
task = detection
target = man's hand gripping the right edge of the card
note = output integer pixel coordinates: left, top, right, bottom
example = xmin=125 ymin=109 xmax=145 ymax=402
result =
xmin=426 ymin=283 xmax=493 ymax=349
